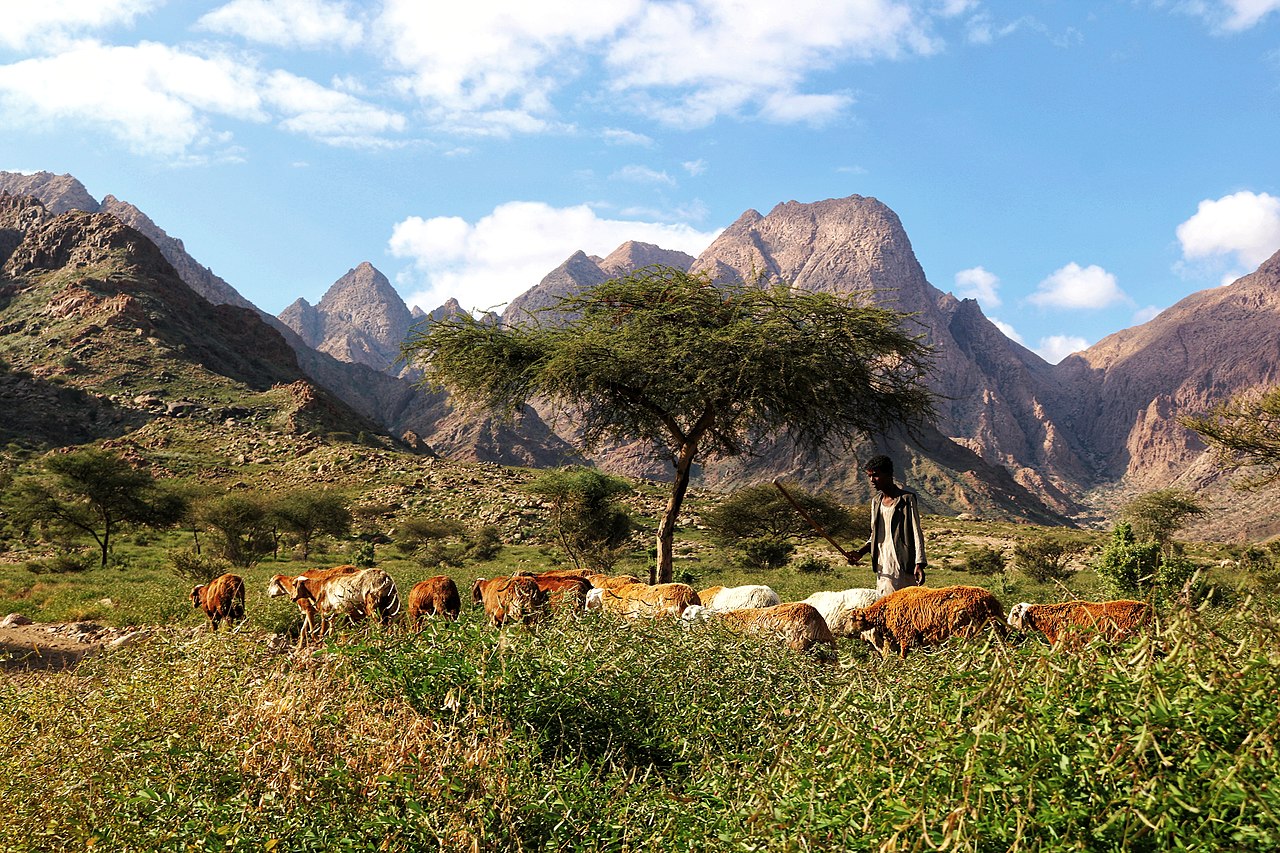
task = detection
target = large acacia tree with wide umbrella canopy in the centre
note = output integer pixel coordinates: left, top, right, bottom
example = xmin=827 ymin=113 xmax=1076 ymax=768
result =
xmin=403 ymin=266 xmax=933 ymax=581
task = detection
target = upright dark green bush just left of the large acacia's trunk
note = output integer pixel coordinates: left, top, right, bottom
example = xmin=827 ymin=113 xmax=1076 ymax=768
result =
xmin=526 ymin=467 xmax=635 ymax=571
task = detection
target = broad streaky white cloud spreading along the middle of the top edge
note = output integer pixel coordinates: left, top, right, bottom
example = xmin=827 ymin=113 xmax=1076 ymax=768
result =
xmin=375 ymin=0 xmax=938 ymax=133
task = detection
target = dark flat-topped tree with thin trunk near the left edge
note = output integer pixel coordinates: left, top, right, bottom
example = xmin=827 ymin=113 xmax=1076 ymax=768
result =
xmin=5 ymin=447 xmax=184 ymax=566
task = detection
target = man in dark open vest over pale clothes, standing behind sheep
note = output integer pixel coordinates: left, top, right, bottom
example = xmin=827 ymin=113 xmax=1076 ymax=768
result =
xmin=849 ymin=456 xmax=925 ymax=596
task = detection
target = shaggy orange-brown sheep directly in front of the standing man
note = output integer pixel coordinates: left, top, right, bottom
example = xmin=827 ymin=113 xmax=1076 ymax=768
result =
xmin=845 ymin=587 xmax=1009 ymax=657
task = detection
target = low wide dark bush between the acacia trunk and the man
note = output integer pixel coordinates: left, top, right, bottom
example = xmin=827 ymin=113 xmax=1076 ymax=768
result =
xmin=703 ymin=483 xmax=869 ymax=546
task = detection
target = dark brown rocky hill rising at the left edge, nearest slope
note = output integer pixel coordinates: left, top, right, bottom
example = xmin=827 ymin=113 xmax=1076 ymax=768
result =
xmin=0 ymin=195 xmax=378 ymax=446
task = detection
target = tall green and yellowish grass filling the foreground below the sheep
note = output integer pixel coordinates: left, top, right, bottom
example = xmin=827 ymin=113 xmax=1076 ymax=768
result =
xmin=0 ymin=596 xmax=1280 ymax=852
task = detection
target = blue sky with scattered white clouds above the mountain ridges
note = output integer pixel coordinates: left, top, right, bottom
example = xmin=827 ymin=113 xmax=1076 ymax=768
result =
xmin=0 ymin=0 xmax=1280 ymax=361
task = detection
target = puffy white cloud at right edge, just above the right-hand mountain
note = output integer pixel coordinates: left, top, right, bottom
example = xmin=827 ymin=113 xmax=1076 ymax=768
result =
xmin=1176 ymin=191 xmax=1280 ymax=272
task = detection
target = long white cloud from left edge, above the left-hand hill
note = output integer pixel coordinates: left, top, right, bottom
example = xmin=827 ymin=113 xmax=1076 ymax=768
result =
xmin=0 ymin=42 xmax=403 ymax=161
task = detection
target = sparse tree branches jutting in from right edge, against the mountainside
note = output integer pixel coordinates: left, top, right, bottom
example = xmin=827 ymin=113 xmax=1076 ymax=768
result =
xmin=1179 ymin=387 xmax=1280 ymax=488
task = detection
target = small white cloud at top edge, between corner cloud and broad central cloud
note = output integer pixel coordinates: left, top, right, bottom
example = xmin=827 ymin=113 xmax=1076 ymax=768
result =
xmin=196 ymin=0 xmax=364 ymax=49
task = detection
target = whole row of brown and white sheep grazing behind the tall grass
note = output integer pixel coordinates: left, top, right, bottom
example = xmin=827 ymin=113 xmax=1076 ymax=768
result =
xmin=191 ymin=566 xmax=1152 ymax=660
